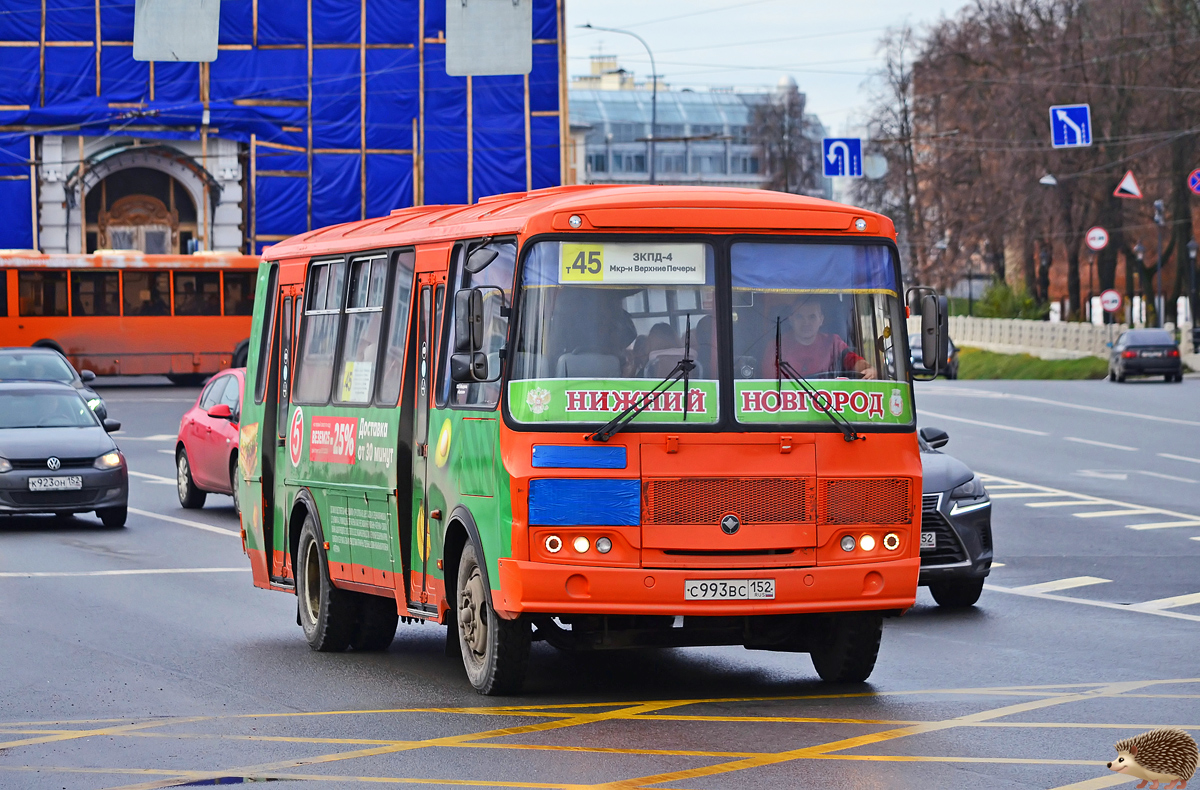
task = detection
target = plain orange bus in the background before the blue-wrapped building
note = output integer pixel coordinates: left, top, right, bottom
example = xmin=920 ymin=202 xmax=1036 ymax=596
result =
xmin=0 ymin=250 xmax=259 ymax=384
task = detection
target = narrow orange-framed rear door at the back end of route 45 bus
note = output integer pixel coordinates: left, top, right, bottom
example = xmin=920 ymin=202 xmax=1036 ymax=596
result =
xmin=263 ymin=286 xmax=304 ymax=582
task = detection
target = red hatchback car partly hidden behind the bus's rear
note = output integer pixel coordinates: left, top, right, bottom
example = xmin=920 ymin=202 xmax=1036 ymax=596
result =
xmin=175 ymin=367 xmax=246 ymax=508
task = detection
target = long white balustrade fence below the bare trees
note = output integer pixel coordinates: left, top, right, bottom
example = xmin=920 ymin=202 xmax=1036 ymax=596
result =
xmin=908 ymin=316 xmax=1196 ymax=367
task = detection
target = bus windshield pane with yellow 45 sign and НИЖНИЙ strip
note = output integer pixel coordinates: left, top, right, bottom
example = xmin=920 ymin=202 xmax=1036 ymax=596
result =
xmin=509 ymin=241 xmax=719 ymax=424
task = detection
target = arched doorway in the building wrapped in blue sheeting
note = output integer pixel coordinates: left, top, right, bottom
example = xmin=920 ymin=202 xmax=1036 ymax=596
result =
xmin=84 ymin=167 xmax=198 ymax=255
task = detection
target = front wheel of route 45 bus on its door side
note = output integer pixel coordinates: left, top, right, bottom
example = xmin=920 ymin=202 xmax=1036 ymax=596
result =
xmin=455 ymin=540 xmax=530 ymax=696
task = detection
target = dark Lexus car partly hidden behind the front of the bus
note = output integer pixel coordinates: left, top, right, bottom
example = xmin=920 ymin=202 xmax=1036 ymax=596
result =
xmin=917 ymin=427 xmax=992 ymax=609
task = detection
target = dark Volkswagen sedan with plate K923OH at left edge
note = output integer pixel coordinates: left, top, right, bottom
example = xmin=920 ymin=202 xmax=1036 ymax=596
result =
xmin=0 ymin=382 xmax=130 ymax=527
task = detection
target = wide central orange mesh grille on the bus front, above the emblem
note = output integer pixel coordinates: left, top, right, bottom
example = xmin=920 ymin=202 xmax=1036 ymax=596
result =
xmin=642 ymin=478 xmax=816 ymax=525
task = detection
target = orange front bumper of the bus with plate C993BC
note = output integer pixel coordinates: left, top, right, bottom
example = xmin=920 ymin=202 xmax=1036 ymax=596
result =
xmin=492 ymin=557 xmax=920 ymax=617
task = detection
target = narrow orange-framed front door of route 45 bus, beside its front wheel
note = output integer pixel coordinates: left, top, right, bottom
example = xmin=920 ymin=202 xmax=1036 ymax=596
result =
xmin=408 ymin=273 xmax=445 ymax=614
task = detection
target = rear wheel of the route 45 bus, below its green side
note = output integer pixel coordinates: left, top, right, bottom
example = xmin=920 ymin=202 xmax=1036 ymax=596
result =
xmin=296 ymin=511 xmax=356 ymax=653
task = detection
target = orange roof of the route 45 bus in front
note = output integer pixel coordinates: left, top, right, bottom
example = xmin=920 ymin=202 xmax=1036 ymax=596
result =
xmin=263 ymin=185 xmax=895 ymax=259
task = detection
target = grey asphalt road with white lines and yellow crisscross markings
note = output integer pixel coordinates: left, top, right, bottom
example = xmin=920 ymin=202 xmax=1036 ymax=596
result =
xmin=0 ymin=379 xmax=1200 ymax=790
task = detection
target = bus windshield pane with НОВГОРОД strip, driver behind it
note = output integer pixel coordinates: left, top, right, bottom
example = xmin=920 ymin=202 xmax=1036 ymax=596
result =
xmin=730 ymin=241 xmax=912 ymax=423
